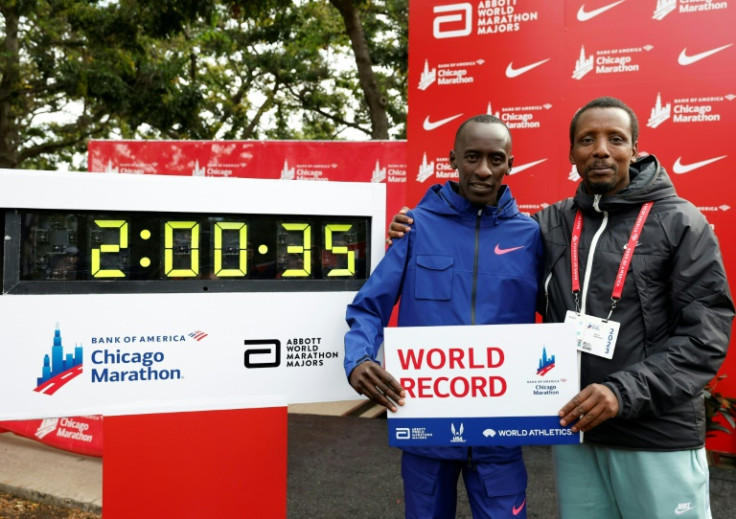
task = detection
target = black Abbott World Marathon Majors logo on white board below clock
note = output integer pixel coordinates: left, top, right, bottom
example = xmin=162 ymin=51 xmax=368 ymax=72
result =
xmin=243 ymin=337 xmax=340 ymax=369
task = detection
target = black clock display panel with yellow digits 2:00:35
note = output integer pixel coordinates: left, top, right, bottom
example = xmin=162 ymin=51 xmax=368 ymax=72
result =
xmin=4 ymin=210 xmax=371 ymax=293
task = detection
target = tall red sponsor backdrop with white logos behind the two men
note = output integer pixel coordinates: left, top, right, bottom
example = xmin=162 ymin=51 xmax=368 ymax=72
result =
xmin=406 ymin=0 xmax=736 ymax=453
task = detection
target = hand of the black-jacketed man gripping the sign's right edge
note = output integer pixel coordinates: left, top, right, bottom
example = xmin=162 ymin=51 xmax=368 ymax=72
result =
xmin=557 ymin=384 xmax=619 ymax=433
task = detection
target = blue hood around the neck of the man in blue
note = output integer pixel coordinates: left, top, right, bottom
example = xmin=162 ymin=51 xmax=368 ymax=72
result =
xmin=417 ymin=181 xmax=519 ymax=220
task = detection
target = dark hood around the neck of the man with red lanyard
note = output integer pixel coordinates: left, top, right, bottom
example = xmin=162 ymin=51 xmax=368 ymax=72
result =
xmin=575 ymin=155 xmax=677 ymax=212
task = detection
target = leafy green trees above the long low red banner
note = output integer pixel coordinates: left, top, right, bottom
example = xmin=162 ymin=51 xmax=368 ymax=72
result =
xmin=0 ymin=0 xmax=407 ymax=169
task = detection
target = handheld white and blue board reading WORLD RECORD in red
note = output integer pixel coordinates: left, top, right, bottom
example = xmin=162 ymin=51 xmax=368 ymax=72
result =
xmin=384 ymin=323 xmax=580 ymax=447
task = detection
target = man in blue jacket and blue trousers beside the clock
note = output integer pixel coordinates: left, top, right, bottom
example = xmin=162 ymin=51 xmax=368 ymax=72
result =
xmin=345 ymin=115 xmax=542 ymax=519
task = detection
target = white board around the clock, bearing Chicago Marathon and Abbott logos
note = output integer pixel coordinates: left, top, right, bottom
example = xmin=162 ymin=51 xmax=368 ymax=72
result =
xmin=0 ymin=170 xmax=385 ymax=420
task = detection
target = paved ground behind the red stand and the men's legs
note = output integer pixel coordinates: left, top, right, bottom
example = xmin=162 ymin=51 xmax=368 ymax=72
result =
xmin=0 ymin=413 xmax=736 ymax=519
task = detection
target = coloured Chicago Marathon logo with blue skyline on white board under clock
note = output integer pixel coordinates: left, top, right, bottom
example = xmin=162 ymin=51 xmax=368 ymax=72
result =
xmin=34 ymin=326 xmax=208 ymax=395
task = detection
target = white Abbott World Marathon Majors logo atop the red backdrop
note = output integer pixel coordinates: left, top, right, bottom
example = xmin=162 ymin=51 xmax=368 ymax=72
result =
xmin=432 ymin=0 xmax=539 ymax=40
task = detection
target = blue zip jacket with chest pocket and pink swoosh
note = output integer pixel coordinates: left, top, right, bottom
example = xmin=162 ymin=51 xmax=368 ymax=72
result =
xmin=345 ymin=182 xmax=542 ymax=461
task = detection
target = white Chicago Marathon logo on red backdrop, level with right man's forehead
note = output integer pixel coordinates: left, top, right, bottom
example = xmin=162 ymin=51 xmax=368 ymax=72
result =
xmin=647 ymin=93 xmax=736 ymax=128
